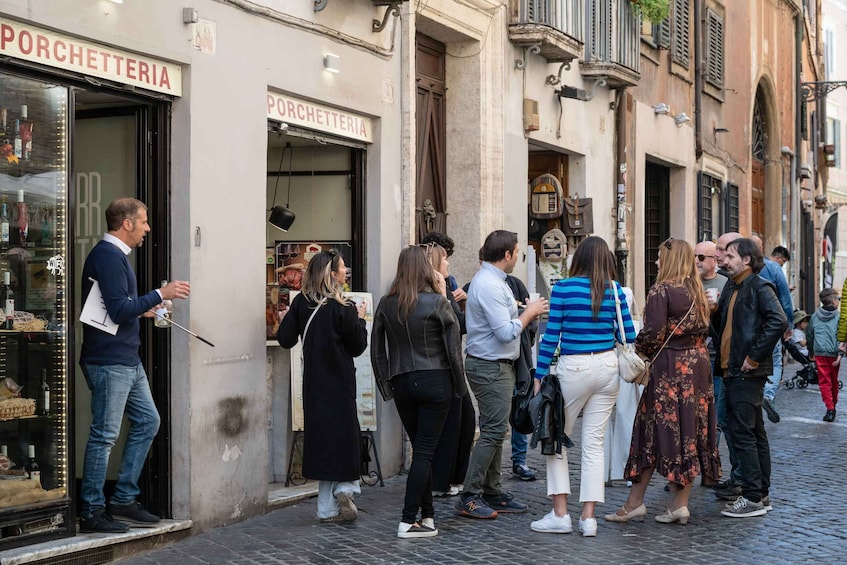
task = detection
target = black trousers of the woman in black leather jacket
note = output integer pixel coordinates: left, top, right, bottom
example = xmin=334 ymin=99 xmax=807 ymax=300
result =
xmin=392 ymin=369 xmax=453 ymax=524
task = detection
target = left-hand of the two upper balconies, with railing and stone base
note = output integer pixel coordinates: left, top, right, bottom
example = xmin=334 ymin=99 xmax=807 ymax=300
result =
xmin=509 ymin=0 xmax=586 ymax=62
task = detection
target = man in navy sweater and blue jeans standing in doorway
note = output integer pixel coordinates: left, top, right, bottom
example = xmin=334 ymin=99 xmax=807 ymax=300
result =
xmin=79 ymin=198 xmax=191 ymax=533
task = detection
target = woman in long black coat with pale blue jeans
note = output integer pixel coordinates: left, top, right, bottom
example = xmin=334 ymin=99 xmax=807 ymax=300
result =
xmin=277 ymin=250 xmax=368 ymax=520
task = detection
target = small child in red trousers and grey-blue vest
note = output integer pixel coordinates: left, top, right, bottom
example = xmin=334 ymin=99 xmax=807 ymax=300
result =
xmin=806 ymin=288 xmax=841 ymax=422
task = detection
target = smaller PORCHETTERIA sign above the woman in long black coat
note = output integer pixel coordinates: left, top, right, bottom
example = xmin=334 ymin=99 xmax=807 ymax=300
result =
xmin=268 ymin=92 xmax=373 ymax=143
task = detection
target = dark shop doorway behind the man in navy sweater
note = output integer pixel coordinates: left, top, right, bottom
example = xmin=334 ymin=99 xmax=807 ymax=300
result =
xmin=69 ymin=88 xmax=171 ymax=516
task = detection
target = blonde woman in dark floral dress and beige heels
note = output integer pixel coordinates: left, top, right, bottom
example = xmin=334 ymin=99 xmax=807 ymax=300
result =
xmin=606 ymin=239 xmax=721 ymax=524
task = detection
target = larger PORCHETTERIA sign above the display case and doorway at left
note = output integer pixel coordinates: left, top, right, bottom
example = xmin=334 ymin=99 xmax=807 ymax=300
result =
xmin=0 ymin=18 xmax=182 ymax=96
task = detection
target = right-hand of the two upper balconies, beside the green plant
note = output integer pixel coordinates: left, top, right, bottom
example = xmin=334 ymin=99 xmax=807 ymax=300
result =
xmin=580 ymin=0 xmax=641 ymax=87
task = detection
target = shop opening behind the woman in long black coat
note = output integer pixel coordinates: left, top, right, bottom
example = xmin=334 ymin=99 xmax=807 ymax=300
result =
xmin=265 ymin=122 xmax=364 ymax=484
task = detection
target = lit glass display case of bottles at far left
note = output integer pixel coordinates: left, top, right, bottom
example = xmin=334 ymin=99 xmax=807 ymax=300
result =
xmin=0 ymin=73 xmax=75 ymax=550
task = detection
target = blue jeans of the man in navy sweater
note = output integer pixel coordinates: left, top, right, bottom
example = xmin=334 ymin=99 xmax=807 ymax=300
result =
xmin=80 ymin=363 xmax=160 ymax=518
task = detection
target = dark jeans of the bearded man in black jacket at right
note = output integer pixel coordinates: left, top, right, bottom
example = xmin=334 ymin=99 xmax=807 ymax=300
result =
xmin=723 ymin=377 xmax=771 ymax=502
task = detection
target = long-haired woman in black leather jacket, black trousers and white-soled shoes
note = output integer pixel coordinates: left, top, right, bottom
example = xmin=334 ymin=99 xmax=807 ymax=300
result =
xmin=371 ymin=246 xmax=465 ymax=538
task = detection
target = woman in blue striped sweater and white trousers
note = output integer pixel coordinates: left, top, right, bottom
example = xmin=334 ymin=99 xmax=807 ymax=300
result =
xmin=531 ymin=236 xmax=635 ymax=537
